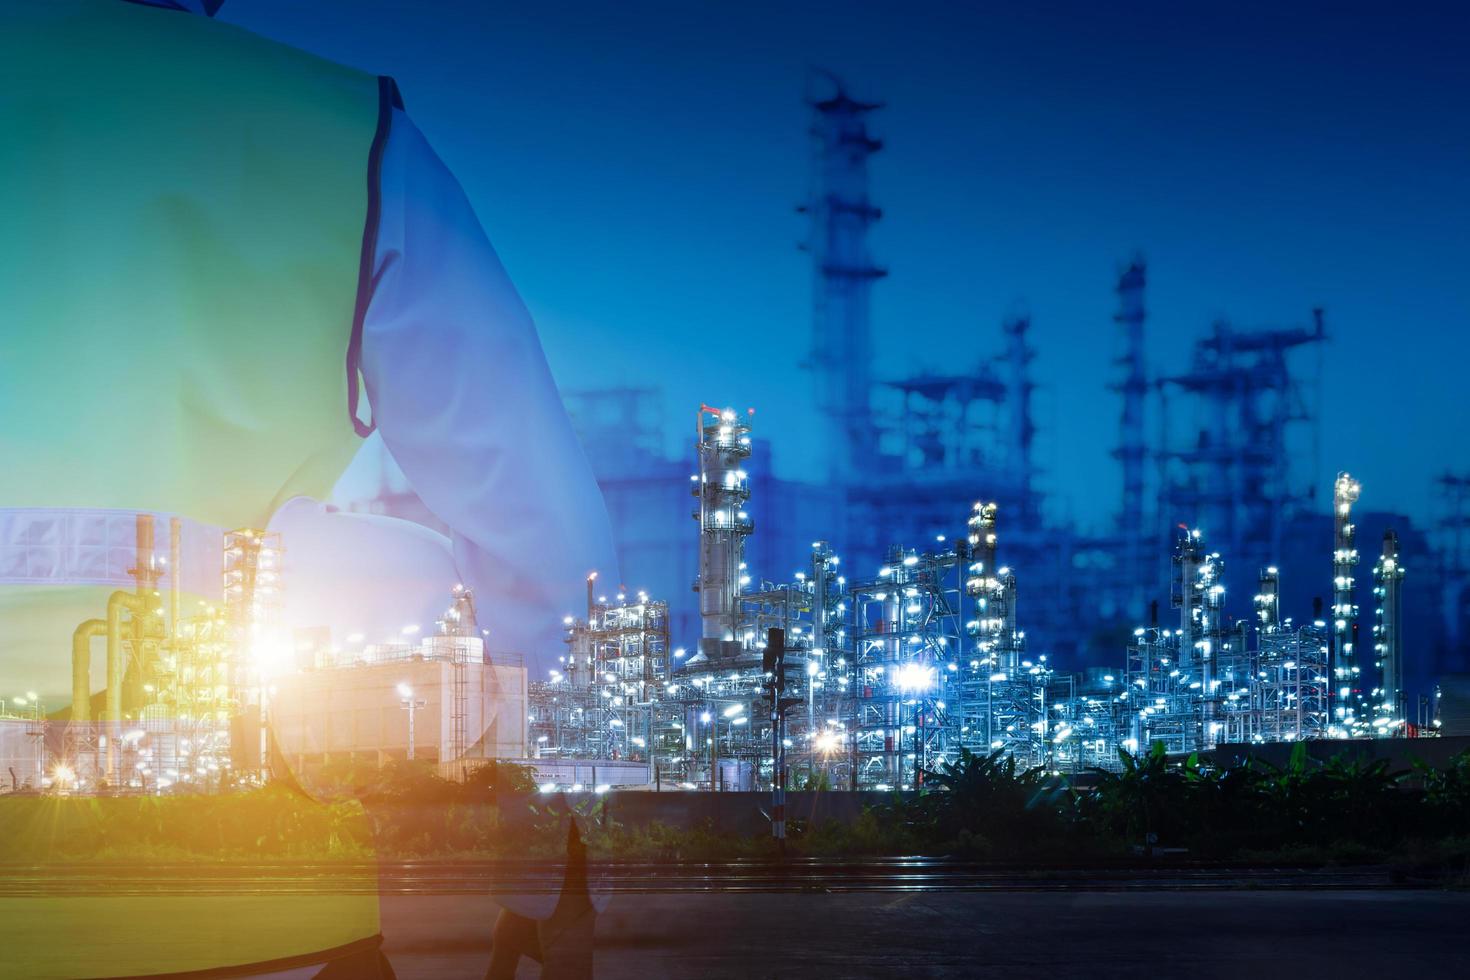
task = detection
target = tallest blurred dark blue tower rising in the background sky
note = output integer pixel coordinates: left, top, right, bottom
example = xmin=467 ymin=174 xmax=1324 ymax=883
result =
xmin=797 ymin=75 xmax=886 ymax=483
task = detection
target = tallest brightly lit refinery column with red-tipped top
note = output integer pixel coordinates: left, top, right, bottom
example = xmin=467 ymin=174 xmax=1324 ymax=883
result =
xmin=692 ymin=406 xmax=754 ymax=661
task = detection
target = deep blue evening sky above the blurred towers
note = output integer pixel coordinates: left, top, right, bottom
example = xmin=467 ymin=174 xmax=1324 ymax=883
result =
xmin=232 ymin=0 xmax=1470 ymax=527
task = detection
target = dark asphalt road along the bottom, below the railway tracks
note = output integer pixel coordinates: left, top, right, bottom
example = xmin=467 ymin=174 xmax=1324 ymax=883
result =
xmin=382 ymin=889 xmax=1470 ymax=980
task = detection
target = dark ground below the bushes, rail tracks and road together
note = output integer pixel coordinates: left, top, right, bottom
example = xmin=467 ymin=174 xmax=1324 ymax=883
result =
xmin=0 ymin=860 xmax=1470 ymax=980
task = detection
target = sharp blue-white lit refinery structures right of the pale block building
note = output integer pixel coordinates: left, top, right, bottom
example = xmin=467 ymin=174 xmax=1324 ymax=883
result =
xmin=529 ymin=406 xmax=1433 ymax=789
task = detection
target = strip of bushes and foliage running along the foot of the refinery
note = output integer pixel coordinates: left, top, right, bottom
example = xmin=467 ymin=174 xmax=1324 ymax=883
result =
xmin=11 ymin=745 xmax=1470 ymax=863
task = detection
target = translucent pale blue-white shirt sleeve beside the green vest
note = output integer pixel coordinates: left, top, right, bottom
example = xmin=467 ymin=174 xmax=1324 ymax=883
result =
xmin=362 ymin=110 xmax=617 ymax=663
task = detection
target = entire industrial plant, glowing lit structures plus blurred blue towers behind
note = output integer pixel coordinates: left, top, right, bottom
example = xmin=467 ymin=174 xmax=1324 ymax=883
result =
xmin=0 ymin=76 xmax=1470 ymax=793
